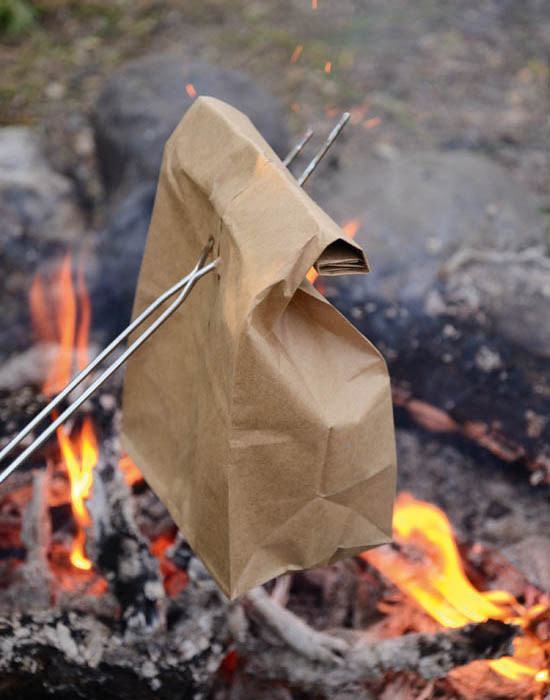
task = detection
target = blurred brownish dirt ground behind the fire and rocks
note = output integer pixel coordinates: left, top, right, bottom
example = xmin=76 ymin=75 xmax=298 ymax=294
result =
xmin=0 ymin=0 xmax=550 ymax=202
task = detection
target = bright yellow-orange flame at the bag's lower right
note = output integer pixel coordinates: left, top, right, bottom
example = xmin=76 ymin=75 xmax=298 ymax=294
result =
xmin=361 ymin=494 xmax=550 ymax=682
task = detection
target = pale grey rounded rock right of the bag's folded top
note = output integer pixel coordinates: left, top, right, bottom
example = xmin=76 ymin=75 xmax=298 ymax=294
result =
xmin=320 ymin=151 xmax=543 ymax=302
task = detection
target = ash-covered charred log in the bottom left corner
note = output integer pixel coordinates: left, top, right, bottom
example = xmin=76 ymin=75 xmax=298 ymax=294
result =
xmin=0 ymin=560 xmax=227 ymax=700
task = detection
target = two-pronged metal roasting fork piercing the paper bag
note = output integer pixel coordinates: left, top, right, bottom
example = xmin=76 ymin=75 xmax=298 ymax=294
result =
xmin=0 ymin=112 xmax=350 ymax=484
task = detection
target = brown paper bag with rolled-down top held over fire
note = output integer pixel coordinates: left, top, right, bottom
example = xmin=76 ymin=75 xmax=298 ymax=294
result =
xmin=123 ymin=97 xmax=395 ymax=598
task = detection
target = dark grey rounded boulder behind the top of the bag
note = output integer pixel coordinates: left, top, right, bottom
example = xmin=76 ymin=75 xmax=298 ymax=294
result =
xmin=93 ymin=55 xmax=294 ymax=194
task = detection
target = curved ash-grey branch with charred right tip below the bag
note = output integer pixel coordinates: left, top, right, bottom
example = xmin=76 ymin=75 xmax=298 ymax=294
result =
xmin=230 ymin=588 xmax=518 ymax=697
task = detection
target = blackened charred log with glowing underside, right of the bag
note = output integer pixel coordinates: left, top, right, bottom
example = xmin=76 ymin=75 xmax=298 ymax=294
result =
xmin=332 ymin=289 xmax=550 ymax=485
